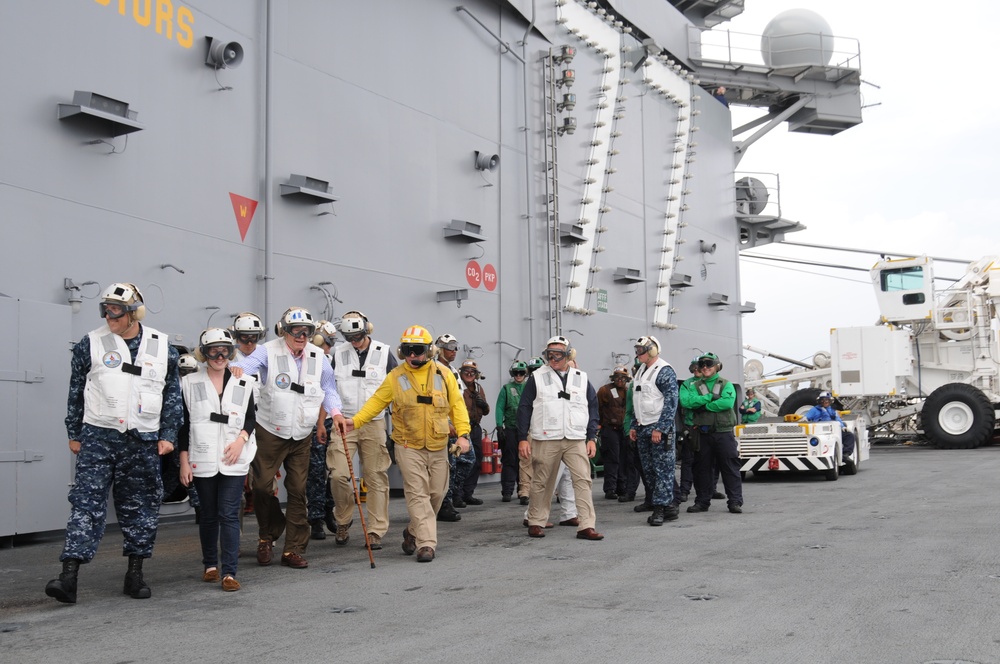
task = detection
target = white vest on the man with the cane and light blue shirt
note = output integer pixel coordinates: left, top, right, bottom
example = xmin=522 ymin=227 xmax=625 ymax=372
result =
xmin=257 ymin=338 xmax=326 ymax=440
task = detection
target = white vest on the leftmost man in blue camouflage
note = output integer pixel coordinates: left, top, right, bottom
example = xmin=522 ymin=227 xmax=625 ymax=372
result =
xmin=83 ymin=325 xmax=169 ymax=433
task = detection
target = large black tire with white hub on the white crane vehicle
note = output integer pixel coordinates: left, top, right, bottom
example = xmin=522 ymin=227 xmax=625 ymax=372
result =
xmin=920 ymin=383 xmax=996 ymax=450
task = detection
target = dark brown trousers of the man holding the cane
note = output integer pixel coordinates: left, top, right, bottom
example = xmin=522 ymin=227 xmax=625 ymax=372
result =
xmin=250 ymin=424 xmax=312 ymax=553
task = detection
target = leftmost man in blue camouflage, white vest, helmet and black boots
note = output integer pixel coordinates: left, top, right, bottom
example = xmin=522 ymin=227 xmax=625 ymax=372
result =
xmin=45 ymin=283 xmax=184 ymax=604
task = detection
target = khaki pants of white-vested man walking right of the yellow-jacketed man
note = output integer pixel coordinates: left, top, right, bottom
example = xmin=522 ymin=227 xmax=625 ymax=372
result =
xmin=528 ymin=438 xmax=597 ymax=532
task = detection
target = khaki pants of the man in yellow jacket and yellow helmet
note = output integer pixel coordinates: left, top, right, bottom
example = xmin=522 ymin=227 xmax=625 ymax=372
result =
xmin=396 ymin=445 xmax=450 ymax=549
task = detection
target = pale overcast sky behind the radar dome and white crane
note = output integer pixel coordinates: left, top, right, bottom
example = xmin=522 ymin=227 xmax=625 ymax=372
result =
xmin=722 ymin=0 xmax=1000 ymax=372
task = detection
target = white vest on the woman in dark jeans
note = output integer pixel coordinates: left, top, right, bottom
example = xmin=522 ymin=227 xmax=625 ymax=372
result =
xmin=181 ymin=369 xmax=257 ymax=477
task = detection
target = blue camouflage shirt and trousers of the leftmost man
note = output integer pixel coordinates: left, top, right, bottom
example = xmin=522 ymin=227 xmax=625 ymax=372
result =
xmin=59 ymin=325 xmax=184 ymax=563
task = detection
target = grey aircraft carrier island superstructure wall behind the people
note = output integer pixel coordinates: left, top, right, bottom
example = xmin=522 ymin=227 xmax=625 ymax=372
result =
xmin=0 ymin=0 xmax=861 ymax=541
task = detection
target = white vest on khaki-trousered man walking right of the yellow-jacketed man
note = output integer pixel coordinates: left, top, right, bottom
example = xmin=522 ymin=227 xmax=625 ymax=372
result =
xmin=530 ymin=366 xmax=590 ymax=440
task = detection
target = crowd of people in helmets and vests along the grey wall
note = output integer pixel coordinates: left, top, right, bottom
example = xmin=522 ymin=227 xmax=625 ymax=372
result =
xmin=45 ymin=283 xmax=743 ymax=603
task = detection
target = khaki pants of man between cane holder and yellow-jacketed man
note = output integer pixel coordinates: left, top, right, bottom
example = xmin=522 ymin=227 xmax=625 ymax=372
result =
xmin=326 ymin=420 xmax=392 ymax=537
